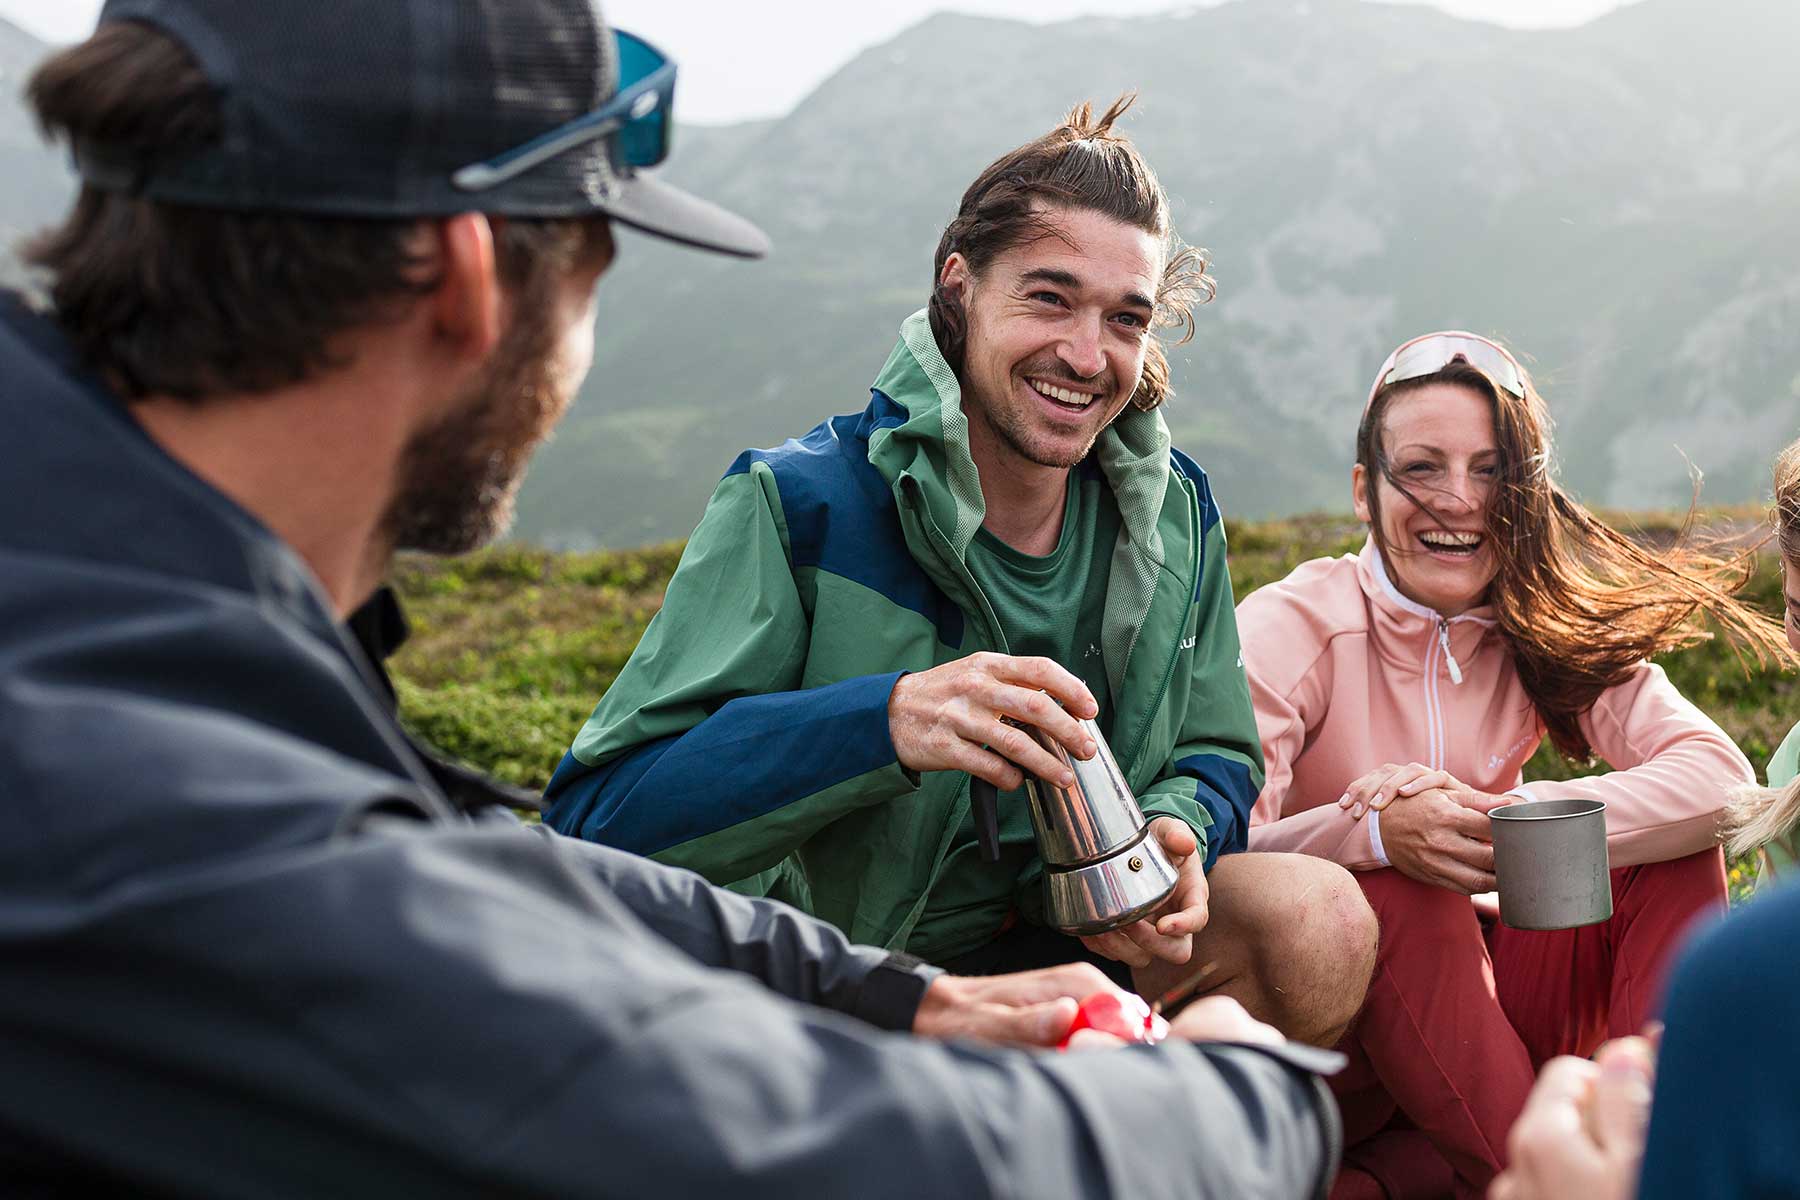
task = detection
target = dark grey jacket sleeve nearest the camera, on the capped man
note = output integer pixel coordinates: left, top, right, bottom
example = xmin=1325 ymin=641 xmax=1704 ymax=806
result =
xmin=10 ymin=793 xmax=1336 ymax=1200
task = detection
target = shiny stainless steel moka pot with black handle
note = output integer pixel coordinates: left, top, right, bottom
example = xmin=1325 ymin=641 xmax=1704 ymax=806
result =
xmin=968 ymin=721 xmax=1175 ymax=937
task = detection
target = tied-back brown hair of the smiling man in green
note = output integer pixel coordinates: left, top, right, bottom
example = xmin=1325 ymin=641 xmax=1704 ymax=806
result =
xmin=927 ymin=92 xmax=1213 ymax=412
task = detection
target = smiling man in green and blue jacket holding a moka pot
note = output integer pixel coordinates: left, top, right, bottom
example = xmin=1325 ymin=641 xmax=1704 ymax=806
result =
xmin=549 ymin=99 xmax=1375 ymax=1045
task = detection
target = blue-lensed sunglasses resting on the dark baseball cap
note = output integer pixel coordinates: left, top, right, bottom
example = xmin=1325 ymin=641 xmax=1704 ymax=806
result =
xmin=450 ymin=29 xmax=675 ymax=193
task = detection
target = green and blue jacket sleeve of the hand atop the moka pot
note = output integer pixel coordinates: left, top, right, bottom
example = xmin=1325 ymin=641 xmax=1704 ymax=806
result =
xmin=545 ymin=462 xmax=918 ymax=883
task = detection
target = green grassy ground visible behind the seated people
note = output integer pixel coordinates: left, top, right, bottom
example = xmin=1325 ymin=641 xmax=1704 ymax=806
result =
xmin=394 ymin=511 xmax=1800 ymax=892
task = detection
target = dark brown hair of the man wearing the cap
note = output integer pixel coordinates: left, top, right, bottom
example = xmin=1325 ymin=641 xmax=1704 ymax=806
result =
xmin=23 ymin=22 xmax=598 ymax=401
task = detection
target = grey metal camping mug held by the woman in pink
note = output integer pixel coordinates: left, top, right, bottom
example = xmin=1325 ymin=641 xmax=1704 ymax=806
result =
xmin=1489 ymin=801 xmax=1613 ymax=928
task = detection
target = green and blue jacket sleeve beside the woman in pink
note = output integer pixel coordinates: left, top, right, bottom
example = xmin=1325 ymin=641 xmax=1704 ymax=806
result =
xmin=1138 ymin=510 xmax=1264 ymax=871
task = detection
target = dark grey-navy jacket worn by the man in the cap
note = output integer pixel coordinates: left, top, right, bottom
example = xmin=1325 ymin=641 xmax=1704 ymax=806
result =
xmin=0 ymin=293 xmax=1336 ymax=1200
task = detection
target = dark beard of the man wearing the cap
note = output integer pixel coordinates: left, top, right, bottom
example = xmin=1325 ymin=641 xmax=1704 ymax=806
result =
xmin=382 ymin=313 xmax=567 ymax=554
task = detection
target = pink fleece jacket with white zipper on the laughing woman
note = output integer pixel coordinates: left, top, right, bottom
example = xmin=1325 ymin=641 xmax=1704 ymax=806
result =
xmin=1237 ymin=540 xmax=1753 ymax=871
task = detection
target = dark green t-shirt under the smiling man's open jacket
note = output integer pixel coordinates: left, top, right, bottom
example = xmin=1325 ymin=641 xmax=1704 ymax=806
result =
xmin=907 ymin=470 xmax=1120 ymax=963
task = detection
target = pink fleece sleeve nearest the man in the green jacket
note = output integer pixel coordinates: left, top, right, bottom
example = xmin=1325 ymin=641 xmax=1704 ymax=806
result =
xmin=1238 ymin=590 xmax=1382 ymax=871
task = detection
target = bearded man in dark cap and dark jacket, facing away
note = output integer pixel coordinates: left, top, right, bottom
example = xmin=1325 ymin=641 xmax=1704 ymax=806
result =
xmin=0 ymin=0 xmax=1336 ymax=1196
